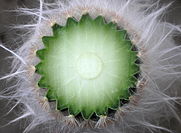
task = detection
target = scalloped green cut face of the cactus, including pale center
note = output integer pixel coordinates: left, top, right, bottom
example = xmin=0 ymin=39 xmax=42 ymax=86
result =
xmin=36 ymin=14 xmax=139 ymax=119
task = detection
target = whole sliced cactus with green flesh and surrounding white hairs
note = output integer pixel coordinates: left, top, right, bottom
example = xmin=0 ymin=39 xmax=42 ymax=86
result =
xmin=0 ymin=0 xmax=181 ymax=133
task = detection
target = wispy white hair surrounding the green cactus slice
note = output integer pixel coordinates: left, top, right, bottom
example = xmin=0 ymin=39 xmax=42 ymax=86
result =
xmin=0 ymin=0 xmax=181 ymax=133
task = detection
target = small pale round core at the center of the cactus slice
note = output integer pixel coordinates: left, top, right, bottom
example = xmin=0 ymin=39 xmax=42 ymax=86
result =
xmin=76 ymin=53 xmax=103 ymax=79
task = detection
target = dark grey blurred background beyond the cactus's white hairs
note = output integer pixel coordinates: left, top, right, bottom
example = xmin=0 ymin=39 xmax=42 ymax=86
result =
xmin=0 ymin=0 xmax=181 ymax=133
